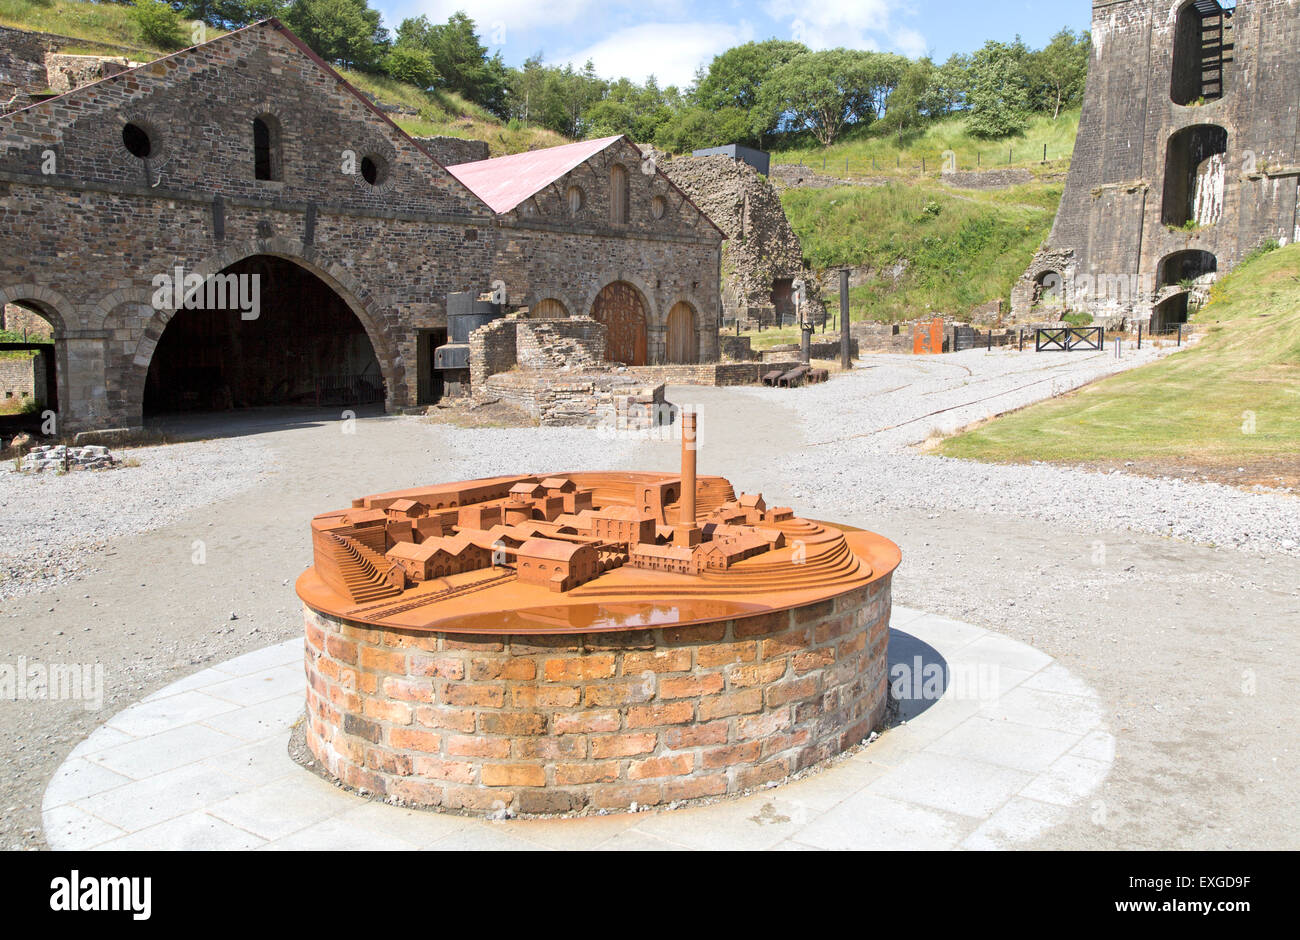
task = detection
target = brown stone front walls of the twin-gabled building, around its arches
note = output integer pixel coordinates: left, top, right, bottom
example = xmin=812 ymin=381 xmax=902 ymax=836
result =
xmin=0 ymin=21 xmax=722 ymax=432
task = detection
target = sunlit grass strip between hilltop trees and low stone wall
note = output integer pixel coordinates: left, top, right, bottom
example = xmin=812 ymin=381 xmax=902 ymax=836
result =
xmin=772 ymin=111 xmax=1079 ymax=178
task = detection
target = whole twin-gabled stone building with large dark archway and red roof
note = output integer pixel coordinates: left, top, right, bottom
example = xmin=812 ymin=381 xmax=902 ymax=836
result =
xmin=0 ymin=20 xmax=723 ymax=432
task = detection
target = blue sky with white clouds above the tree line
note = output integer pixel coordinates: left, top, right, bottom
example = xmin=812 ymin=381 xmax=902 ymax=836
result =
xmin=371 ymin=0 xmax=1092 ymax=86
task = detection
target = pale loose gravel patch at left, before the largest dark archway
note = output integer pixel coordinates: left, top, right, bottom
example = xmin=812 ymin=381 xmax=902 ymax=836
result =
xmin=0 ymin=438 xmax=273 ymax=599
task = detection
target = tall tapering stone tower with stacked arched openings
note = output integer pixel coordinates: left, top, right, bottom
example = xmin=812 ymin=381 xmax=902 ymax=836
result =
xmin=1011 ymin=0 xmax=1300 ymax=329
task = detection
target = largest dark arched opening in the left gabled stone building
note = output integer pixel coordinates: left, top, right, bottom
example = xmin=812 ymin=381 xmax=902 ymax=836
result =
xmin=144 ymin=255 xmax=384 ymax=416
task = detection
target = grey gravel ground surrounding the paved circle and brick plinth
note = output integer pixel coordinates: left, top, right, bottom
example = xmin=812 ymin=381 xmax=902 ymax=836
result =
xmin=0 ymin=351 xmax=1300 ymax=849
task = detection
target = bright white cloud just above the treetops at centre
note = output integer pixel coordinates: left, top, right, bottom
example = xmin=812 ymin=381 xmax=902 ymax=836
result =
xmin=558 ymin=22 xmax=754 ymax=88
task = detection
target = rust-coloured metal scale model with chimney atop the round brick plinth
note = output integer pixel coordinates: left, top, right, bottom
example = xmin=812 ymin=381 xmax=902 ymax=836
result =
xmin=298 ymin=411 xmax=900 ymax=633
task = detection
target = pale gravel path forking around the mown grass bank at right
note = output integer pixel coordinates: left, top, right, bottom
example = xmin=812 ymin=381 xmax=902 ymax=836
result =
xmin=717 ymin=350 xmax=1300 ymax=556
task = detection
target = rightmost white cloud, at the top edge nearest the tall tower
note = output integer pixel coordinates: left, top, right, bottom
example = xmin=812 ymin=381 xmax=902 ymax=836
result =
xmin=763 ymin=0 xmax=927 ymax=57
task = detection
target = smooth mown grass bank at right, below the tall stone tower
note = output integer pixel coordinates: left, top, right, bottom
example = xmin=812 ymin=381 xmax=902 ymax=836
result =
xmin=941 ymin=246 xmax=1300 ymax=467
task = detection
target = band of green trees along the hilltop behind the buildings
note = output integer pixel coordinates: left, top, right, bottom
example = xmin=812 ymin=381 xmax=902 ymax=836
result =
xmin=0 ymin=0 xmax=1089 ymax=152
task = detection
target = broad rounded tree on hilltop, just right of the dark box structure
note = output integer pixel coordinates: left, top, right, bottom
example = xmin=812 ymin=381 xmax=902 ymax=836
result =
xmin=750 ymin=49 xmax=888 ymax=147
